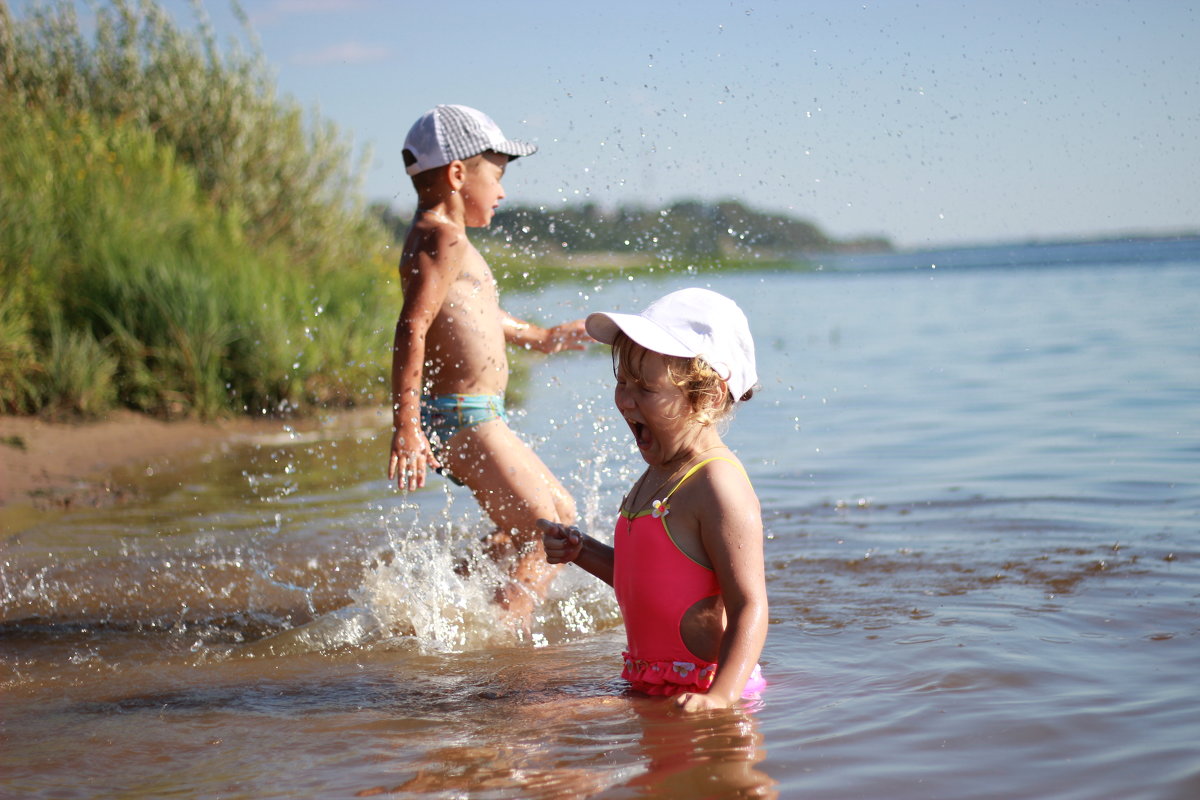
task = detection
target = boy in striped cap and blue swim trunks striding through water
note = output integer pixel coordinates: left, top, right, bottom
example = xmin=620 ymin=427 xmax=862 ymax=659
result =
xmin=388 ymin=106 xmax=590 ymax=620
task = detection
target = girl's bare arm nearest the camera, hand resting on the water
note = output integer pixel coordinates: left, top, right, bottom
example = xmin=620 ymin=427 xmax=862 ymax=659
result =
xmin=672 ymin=463 xmax=767 ymax=711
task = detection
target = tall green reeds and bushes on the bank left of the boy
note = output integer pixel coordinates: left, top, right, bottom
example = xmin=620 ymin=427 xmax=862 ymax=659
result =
xmin=0 ymin=0 xmax=398 ymax=416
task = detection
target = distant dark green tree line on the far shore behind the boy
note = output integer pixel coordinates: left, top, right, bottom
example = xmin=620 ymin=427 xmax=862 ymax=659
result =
xmin=373 ymin=200 xmax=892 ymax=258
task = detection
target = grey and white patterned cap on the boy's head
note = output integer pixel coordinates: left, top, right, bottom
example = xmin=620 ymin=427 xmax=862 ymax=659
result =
xmin=404 ymin=106 xmax=538 ymax=175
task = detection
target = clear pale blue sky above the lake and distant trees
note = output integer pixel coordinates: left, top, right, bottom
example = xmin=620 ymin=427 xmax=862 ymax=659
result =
xmin=14 ymin=0 xmax=1200 ymax=247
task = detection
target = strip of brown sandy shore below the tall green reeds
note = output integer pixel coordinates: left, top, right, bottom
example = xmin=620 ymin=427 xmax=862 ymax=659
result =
xmin=0 ymin=409 xmax=383 ymax=510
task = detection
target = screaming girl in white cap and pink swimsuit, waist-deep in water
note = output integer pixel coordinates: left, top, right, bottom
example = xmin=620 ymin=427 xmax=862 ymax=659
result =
xmin=539 ymin=289 xmax=767 ymax=711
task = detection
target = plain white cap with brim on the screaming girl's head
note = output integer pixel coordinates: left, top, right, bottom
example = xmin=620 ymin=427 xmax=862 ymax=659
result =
xmin=584 ymin=288 xmax=758 ymax=401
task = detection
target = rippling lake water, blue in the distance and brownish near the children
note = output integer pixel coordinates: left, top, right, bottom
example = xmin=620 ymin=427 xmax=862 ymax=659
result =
xmin=0 ymin=241 xmax=1200 ymax=800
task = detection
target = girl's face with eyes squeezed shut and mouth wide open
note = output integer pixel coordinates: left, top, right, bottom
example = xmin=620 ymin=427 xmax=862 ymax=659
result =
xmin=613 ymin=348 xmax=703 ymax=467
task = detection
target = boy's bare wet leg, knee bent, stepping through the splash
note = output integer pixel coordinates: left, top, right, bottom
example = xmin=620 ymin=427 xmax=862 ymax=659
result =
xmin=446 ymin=420 xmax=575 ymax=614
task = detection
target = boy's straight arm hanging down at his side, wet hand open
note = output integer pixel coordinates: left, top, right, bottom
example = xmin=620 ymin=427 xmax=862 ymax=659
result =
xmin=388 ymin=225 xmax=464 ymax=491
